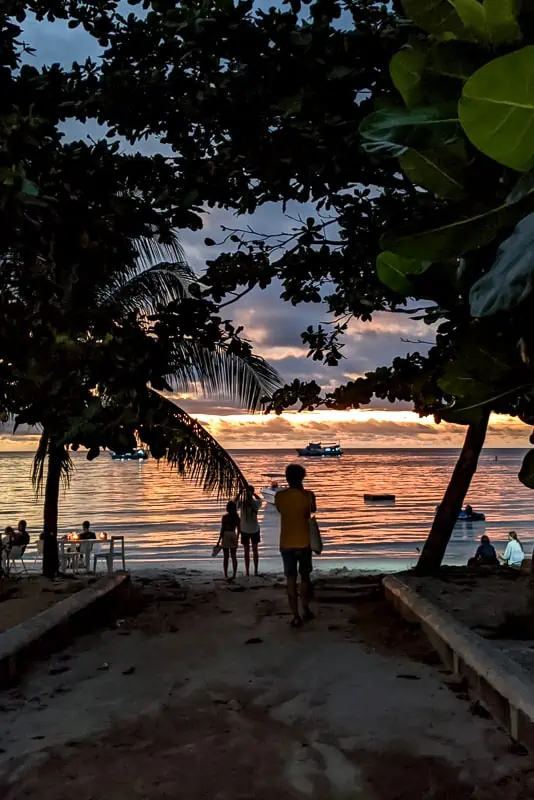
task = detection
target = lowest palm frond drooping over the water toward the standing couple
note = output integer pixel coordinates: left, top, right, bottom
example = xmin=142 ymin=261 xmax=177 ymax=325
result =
xmin=144 ymin=390 xmax=247 ymax=499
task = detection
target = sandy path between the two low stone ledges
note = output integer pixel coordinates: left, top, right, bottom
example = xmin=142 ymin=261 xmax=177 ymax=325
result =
xmin=0 ymin=581 xmax=534 ymax=800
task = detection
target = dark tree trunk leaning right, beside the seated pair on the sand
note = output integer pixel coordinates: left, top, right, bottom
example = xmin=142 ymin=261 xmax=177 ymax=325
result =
xmin=415 ymin=412 xmax=489 ymax=575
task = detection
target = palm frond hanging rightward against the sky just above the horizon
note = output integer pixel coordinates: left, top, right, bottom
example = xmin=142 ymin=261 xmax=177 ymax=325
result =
xmin=168 ymin=340 xmax=282 ymax=411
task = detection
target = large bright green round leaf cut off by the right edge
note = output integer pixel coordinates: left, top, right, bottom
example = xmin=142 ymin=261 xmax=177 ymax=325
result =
xmin=459 ymin=45 xmax=534 ymax=172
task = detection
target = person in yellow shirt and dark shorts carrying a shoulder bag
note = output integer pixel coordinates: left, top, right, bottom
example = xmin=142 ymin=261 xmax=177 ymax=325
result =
xmin=275 ymin=464 xmax=317 ymax=628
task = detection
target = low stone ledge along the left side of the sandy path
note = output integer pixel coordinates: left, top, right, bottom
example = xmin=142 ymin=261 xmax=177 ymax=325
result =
xmin=0 ymin=573 xmax=130 ymax=688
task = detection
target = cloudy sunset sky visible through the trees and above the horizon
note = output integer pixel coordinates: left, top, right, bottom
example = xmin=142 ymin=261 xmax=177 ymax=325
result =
xmin=0 ymin=7 xmax=529 ymax=450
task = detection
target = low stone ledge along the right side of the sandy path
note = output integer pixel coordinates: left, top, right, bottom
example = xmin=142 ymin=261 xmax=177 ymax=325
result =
xmin=382 ymin=575 xmax=534 ymax=752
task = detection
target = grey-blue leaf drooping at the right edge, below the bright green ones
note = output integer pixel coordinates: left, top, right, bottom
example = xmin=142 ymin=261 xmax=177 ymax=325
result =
xmin=469 ymin=214 xmax=534 ymax=317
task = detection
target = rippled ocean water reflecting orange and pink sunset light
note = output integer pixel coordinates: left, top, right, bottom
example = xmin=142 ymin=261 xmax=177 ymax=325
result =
xmin=0 ymin=449 xmax=534 ymax=571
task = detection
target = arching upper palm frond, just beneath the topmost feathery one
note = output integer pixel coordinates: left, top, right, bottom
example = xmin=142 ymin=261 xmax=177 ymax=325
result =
xmin=97 ymin=261 xmax=196 ymax=315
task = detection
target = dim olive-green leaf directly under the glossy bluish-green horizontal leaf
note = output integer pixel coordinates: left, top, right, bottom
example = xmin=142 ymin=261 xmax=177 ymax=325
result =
xmin=399 ymin=143 xmax=466 ymax=198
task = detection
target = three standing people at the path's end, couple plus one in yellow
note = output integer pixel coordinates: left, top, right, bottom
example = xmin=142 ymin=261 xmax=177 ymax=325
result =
xmin=216 ymin=464 xmax=317 ymax=628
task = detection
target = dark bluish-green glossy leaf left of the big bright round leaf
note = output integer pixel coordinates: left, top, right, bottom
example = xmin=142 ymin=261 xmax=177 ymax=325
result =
xmin=360 ymin=106 xmax=459 ymax=156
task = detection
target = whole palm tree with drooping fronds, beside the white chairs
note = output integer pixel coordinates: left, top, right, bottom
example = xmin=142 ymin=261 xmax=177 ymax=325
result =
xmin=21 ymin=239 xmax=280 ymax=576
